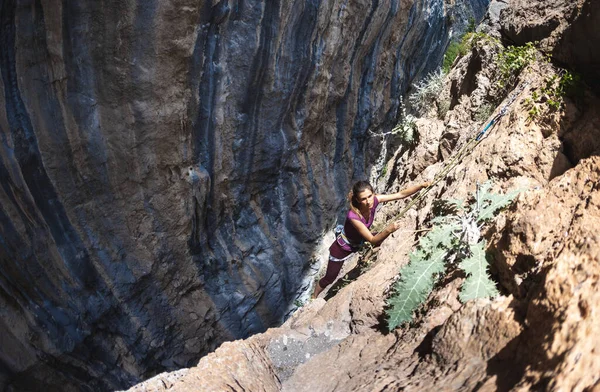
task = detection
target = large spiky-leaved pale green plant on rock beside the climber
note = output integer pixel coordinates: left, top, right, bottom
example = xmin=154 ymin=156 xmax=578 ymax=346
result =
xmin=387 ymin=183 xmax=520 ymax=330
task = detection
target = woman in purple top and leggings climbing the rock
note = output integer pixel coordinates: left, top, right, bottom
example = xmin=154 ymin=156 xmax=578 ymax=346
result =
xmin=313 ymin=181 xmax=431 ymax=298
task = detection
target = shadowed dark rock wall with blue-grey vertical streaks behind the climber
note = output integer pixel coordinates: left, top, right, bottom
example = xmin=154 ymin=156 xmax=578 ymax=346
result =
xmin=0 ymin=0 xmax=487 ymax=391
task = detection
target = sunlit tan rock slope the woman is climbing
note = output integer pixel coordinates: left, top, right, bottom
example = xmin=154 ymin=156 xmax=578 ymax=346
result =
xmin=132 ymin=1 xmax=600 ymax=392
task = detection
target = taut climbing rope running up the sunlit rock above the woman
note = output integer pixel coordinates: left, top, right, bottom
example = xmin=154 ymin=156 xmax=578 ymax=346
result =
xmin=392 ymin=81 xmax=529 ymax=221
